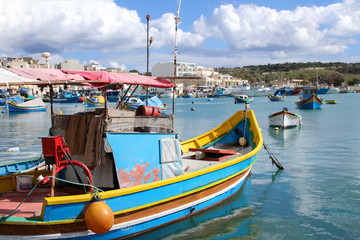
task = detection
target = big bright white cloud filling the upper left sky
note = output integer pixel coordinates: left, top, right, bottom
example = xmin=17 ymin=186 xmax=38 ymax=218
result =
xmin=0 ymin=0 xmax=146 ymax=53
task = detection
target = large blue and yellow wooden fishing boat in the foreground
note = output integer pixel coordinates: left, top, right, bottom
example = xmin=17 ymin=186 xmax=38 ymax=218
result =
xmin=0 ymin=69 xmax=263 ymax=239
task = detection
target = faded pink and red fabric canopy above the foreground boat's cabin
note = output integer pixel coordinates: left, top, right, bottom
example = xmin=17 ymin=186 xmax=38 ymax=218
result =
xmin=7 ymin=68 xmax=174 ymax=88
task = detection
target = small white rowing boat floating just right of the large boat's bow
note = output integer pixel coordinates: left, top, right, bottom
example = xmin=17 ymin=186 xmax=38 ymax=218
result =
xmin=268 ymin=108 xmax=301 ymax=128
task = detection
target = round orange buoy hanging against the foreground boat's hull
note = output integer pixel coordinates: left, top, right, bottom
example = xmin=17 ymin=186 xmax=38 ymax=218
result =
xmin=85 ymin=201 xmax=114 ymax=234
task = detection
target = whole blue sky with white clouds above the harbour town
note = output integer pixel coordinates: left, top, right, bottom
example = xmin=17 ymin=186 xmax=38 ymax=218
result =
xmin=0 ymin=0 xmax=360 ymax=72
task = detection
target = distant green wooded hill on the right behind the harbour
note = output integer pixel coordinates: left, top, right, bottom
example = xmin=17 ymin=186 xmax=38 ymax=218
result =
xmin=215 ymin=62 xmax=360 ymax=86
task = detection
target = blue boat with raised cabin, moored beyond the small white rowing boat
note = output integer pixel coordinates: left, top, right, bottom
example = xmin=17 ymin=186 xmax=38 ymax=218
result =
xmin=295 ymin=87 xmax=323 ymax=109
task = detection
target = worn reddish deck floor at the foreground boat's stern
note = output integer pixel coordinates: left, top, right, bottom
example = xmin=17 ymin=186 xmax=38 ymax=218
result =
xmin=0 ymin=187 xmax=84 ymax=218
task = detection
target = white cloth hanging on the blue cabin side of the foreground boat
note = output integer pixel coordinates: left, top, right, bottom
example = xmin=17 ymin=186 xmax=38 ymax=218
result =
xmin=160 ymin=138 xmax=184 ymax=179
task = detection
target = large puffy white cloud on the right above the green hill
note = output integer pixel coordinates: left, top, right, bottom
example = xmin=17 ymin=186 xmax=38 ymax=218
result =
xmin=194 ymin=0 xmax=360 ymax=56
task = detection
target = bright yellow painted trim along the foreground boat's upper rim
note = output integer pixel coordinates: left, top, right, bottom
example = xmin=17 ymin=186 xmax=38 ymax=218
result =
xmin=44 ymin=110 xmax=263 ymax=205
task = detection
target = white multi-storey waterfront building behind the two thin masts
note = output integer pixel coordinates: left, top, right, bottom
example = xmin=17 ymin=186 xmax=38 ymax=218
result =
xmin=151 ymin=62 xmax=197 ymax=77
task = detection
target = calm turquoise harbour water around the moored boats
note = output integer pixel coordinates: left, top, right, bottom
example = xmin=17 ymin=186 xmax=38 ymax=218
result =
xmin=0 ymin=94 xmax=360 ymax=240
